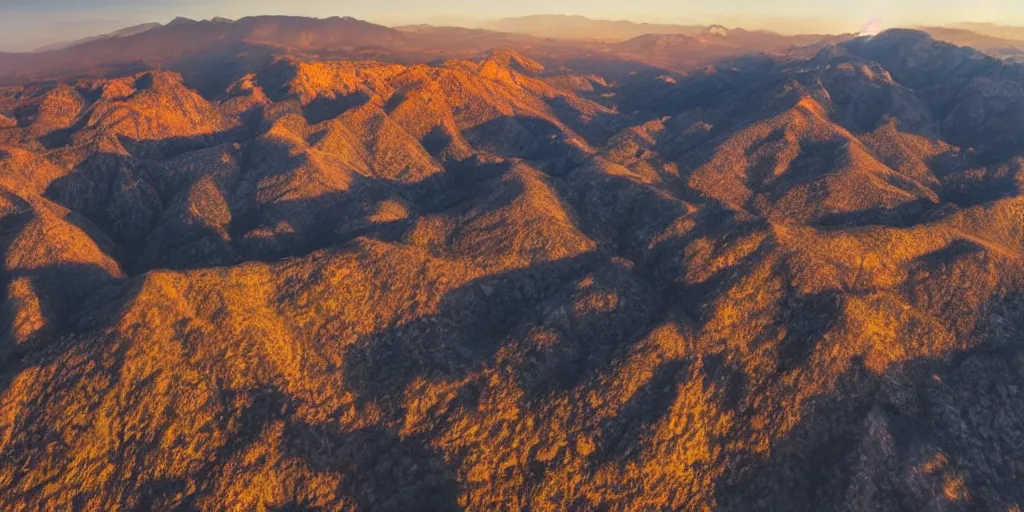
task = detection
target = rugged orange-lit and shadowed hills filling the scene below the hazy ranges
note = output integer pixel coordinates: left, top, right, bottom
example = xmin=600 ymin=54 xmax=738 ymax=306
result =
xmin=0 ymin=20 xmax=1024 ymax=512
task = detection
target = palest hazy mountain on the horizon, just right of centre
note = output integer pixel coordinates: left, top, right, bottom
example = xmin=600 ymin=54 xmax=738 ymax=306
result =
xmin=480 ymin=14 xmax=707 ymax=42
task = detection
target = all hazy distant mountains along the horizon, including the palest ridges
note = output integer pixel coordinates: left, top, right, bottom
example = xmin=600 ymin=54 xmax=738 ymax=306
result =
xmin=0 ymin=15 xmax=1024 ymax=88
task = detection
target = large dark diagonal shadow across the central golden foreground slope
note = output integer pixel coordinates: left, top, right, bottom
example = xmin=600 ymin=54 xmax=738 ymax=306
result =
xmin=341 ymin=242 xmax=667 ymax=495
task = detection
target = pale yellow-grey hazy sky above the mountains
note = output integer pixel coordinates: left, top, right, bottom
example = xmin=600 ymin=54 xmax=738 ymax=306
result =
xmin=0 ymin=0 xmax=1024 ymax=50
